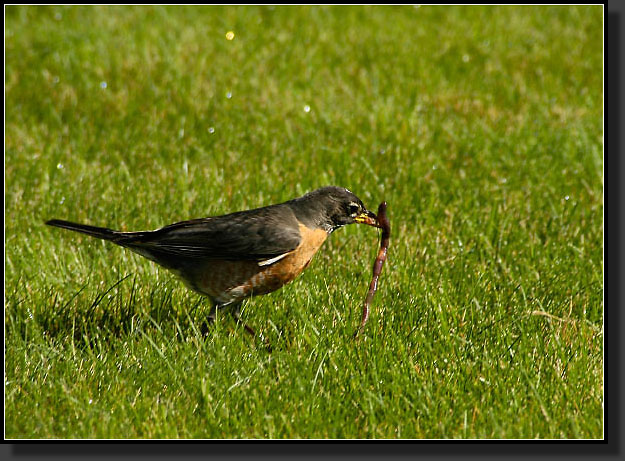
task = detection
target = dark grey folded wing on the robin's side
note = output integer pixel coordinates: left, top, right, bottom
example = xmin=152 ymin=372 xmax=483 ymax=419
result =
xmin=116 ymin=205 xmax=301 ymax=264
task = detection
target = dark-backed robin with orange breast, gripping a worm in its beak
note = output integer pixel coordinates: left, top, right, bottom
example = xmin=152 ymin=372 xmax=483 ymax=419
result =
xmin=46 ymin=186 xmax=379 ymax=334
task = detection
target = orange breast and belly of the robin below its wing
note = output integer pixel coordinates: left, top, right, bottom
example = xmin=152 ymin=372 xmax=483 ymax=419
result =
xmin=190 ymin=224 xmax=328 ymax=303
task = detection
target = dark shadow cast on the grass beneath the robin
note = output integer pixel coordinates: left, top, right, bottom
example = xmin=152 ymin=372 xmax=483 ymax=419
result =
xmin=5 ymin=274 xmax=284 ymax=352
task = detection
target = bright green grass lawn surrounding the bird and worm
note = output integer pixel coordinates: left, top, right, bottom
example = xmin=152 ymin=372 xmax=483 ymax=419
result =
xmin=5 ymin=6 xmax=603 ymax=438
